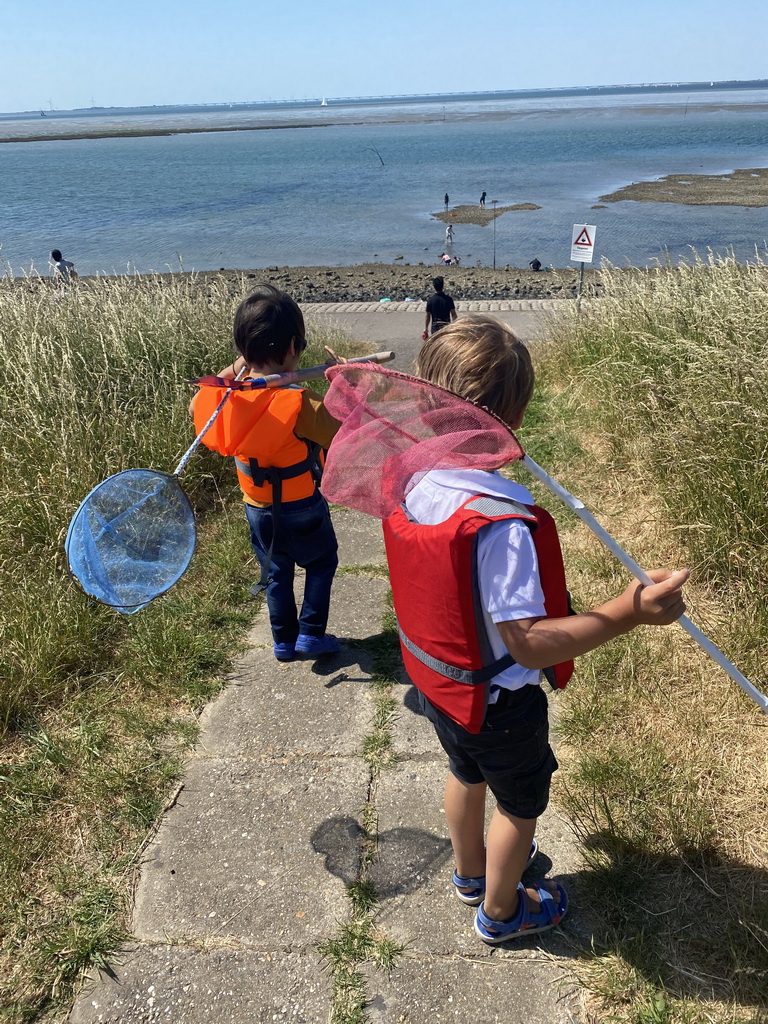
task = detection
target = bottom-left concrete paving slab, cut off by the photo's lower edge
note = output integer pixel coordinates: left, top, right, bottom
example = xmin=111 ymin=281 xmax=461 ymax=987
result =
xmin=70 ymin=945 xmax=331 ymax=1024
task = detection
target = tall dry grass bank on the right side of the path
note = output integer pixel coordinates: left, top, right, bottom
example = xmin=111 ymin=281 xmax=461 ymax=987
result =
xmin=530 ymin=249 xmax=768 ymax=1024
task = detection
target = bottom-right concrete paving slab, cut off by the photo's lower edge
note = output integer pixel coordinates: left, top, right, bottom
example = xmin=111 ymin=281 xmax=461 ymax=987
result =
xmin=365 ymin=947 xmax=578 ymax=1024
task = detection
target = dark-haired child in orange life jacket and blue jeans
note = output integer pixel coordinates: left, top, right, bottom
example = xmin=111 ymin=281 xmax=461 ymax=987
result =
xmin=190 ymin=285 xmax=341 ymax=662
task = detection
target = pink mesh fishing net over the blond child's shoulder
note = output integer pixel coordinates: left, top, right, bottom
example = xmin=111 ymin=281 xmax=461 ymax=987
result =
xmin=323 ymin=362 xmax=524 ymax=519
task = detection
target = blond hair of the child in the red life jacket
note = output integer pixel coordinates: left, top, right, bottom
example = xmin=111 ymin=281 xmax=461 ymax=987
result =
xmin=416 ymin=313 xmax=535 ymax=423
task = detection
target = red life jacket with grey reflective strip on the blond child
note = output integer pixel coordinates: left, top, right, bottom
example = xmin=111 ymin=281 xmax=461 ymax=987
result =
xmin=384 ymin=495 xmax=573 ymax=733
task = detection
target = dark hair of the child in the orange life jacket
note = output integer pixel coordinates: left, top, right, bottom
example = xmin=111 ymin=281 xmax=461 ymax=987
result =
xmin=232 ymin=285 xmax=306 ymax=367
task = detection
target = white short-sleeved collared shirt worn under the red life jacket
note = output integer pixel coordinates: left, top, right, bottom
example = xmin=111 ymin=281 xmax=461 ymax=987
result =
xmin=404 ymin=469 xmax=545 ymax=690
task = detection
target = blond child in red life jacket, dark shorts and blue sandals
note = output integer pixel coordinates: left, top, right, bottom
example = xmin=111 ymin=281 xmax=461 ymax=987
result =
xmin=384 ymin=315 xmax=688 ymax=945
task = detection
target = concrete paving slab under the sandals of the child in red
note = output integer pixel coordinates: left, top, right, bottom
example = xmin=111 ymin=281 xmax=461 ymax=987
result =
xmin=371 ymin=751 xmax=580 ymax=956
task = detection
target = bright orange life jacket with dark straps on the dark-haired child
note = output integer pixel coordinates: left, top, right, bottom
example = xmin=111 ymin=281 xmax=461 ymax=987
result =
xmin=193 ymin=387 xmax=323 ymax=504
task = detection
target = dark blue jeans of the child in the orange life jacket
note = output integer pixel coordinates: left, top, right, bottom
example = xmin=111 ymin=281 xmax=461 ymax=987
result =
xmin=246 ymin=490 xmax=339 ymax=643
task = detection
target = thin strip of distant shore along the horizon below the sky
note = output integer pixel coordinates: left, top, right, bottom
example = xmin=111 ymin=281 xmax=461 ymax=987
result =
xmin=0 ymin=78 xmax=768 ymax=117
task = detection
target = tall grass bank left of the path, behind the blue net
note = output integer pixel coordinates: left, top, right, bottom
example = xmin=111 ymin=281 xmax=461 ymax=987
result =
xmin=0 ymin=275 xmax=354 ymax=1024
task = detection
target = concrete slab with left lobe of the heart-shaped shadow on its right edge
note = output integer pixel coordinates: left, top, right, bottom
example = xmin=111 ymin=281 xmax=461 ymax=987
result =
xmin=133 ymin=758 xmax=369 ymax=950
